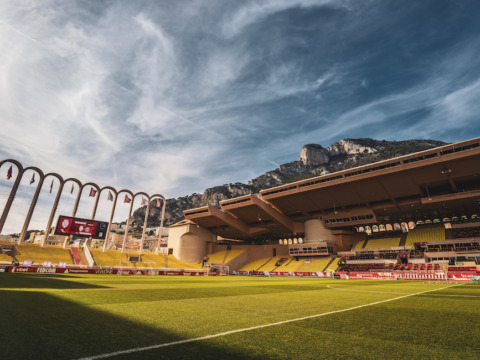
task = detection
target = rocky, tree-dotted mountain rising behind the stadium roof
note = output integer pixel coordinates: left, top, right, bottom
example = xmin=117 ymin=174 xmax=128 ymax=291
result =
xmin=133 ymin=138 xmax=445 ymax=226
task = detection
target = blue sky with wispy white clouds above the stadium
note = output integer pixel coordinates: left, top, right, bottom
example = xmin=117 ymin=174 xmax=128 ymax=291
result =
xmin=0 ymin=0 xmax=480 ymax=233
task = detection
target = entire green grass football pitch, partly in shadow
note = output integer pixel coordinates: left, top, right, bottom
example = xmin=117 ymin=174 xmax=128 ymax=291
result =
xmin=0 ymin=273 xmax=480 ymax=360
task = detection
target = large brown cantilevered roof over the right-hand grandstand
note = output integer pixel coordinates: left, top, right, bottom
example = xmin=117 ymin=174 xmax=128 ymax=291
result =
xmin=184 ymin=138 xmax=480 ymax=239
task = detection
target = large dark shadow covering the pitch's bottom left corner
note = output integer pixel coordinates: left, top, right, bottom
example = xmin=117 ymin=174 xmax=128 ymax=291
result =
xmin=0 ymin=290 xmax=259 ymax=360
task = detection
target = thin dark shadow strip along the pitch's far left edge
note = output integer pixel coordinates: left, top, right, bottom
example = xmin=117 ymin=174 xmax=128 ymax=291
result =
xmin=0 ymin=273 xmax=108 ymax=290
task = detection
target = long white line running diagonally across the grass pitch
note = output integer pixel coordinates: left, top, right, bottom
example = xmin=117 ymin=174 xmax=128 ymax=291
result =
xmin=78 ymin=284 xmax=463 ymax=360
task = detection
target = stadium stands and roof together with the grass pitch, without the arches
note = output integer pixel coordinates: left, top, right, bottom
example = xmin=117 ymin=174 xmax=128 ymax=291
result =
xmin=0 ymin=138 xmax=480 ymax=359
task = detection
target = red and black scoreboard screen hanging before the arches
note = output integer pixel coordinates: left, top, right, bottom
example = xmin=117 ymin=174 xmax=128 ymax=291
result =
xmin=55 ymin=215 xmax=108 ymax=239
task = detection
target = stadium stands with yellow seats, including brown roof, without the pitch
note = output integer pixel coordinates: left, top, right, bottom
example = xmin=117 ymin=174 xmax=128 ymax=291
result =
xmin=0 ymin=138 xmax=480 ymax=275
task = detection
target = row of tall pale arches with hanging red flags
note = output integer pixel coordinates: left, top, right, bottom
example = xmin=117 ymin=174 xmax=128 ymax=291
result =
xmin=0 ymin=159 xmax=165 ymax=252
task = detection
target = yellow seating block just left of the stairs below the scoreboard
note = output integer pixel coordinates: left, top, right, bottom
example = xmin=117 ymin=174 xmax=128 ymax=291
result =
xmin=16 ymin=244 xmax=73 ymax=265
